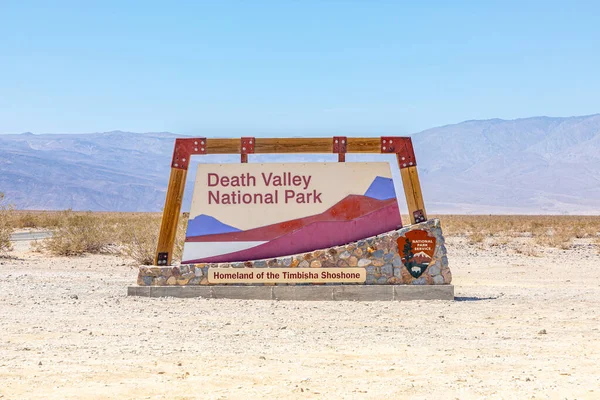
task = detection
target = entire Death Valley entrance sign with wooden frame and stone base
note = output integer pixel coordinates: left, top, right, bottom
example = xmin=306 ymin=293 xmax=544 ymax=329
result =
xmin=129 ymin=136 xmax=453 ymax=300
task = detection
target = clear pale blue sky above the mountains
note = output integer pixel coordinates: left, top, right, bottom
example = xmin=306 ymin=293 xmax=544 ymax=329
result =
xmin=0 ymin=0 xmax=600 ymax=136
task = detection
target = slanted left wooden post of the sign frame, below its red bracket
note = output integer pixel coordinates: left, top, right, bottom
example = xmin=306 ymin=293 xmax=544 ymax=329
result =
xmin=154 ymin=168 xmax=187 ymax=266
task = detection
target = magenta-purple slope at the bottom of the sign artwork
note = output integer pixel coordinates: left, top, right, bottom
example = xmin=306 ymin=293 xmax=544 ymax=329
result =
xmin=185 ymin=199 xmax=402 ymax=264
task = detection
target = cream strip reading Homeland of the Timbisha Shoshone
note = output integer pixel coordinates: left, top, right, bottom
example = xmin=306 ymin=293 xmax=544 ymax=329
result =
xmin=208 ymin=268 xmax=367 ymax=283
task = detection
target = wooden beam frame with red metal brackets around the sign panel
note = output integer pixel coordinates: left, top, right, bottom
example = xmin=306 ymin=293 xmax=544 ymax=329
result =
xmin=154 ymin=136 xmax=427 ymax=266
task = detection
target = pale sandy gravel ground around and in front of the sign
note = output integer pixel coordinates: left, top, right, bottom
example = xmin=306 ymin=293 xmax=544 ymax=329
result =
xmin=0 ymin=237 xmax=600 ymax=399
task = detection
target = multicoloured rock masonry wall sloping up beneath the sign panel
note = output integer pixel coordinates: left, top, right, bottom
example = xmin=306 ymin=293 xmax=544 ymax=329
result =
xmin=137 ymin=219 xmax=452 ymax=286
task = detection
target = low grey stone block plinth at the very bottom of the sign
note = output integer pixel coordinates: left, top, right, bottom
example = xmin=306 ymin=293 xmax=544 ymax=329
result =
xmin=127 ymin=285 xmax=454 ymax=301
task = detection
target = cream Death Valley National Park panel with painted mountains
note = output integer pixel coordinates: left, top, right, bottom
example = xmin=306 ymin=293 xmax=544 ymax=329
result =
xmin=183 ymin=163 xmax=402 ymax=264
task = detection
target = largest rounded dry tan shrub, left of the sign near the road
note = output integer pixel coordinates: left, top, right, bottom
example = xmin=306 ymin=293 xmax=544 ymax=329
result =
xmin=41 ymin=211 xmax=117 ymax=256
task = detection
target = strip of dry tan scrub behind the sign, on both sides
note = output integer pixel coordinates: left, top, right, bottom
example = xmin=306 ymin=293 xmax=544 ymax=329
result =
xmin=10 ymin=209 xmax=600 ymax=265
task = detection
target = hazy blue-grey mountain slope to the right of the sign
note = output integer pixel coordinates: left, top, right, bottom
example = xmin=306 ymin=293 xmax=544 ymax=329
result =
xmin=413 ymin=114 xmax=600 ymax=214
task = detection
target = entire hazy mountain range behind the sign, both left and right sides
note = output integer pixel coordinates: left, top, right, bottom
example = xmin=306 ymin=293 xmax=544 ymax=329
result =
xmin=0 ymin=115 xmax=600 ymax=214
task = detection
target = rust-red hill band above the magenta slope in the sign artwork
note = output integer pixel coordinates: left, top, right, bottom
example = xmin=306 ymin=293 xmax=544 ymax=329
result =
xmin=186 ymin=195 xmax=402 ymax=247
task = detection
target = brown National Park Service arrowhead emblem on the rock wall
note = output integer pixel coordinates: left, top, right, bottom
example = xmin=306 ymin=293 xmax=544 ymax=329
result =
xmin=398 ymin=229 xmax=435 ymax=278
